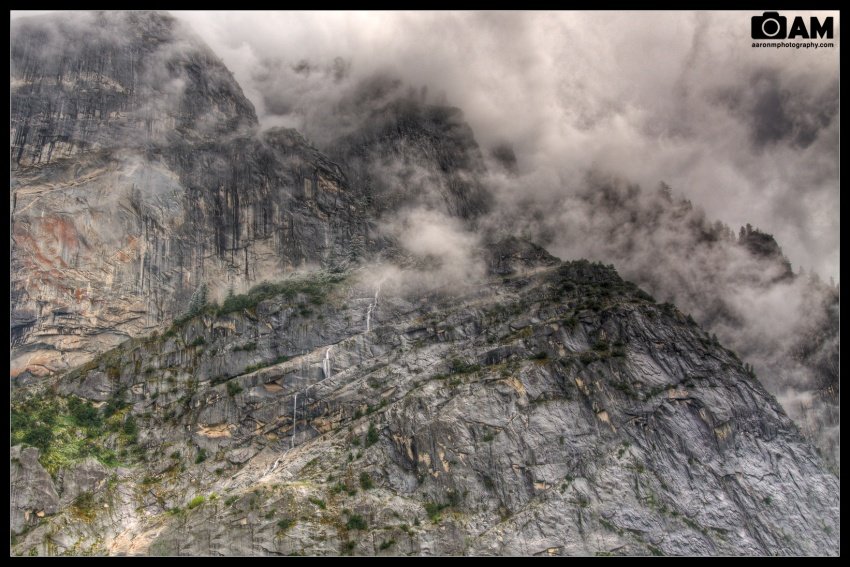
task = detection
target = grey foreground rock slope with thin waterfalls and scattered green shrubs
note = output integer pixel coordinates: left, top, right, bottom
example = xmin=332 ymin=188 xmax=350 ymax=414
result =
xmin=12 ymin=253 xmax=840 ymax=555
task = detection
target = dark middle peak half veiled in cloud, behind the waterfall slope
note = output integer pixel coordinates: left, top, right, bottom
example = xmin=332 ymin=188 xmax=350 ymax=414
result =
xmin=328 ymin=76 xmax=490 ymax=219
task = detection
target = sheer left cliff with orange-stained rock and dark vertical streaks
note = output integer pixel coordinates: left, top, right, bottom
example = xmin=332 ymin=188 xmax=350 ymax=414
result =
xmin=10 ymin=12 xmax=367 ymax=378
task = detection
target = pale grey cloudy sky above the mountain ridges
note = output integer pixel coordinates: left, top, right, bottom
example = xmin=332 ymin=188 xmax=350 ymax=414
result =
xmin=13 ymin=12 xmax=840 ymax=281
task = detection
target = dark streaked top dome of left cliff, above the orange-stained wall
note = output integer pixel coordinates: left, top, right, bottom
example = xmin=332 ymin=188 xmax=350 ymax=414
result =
xmin=10 ymin=12 xmax=257 ymax=167
